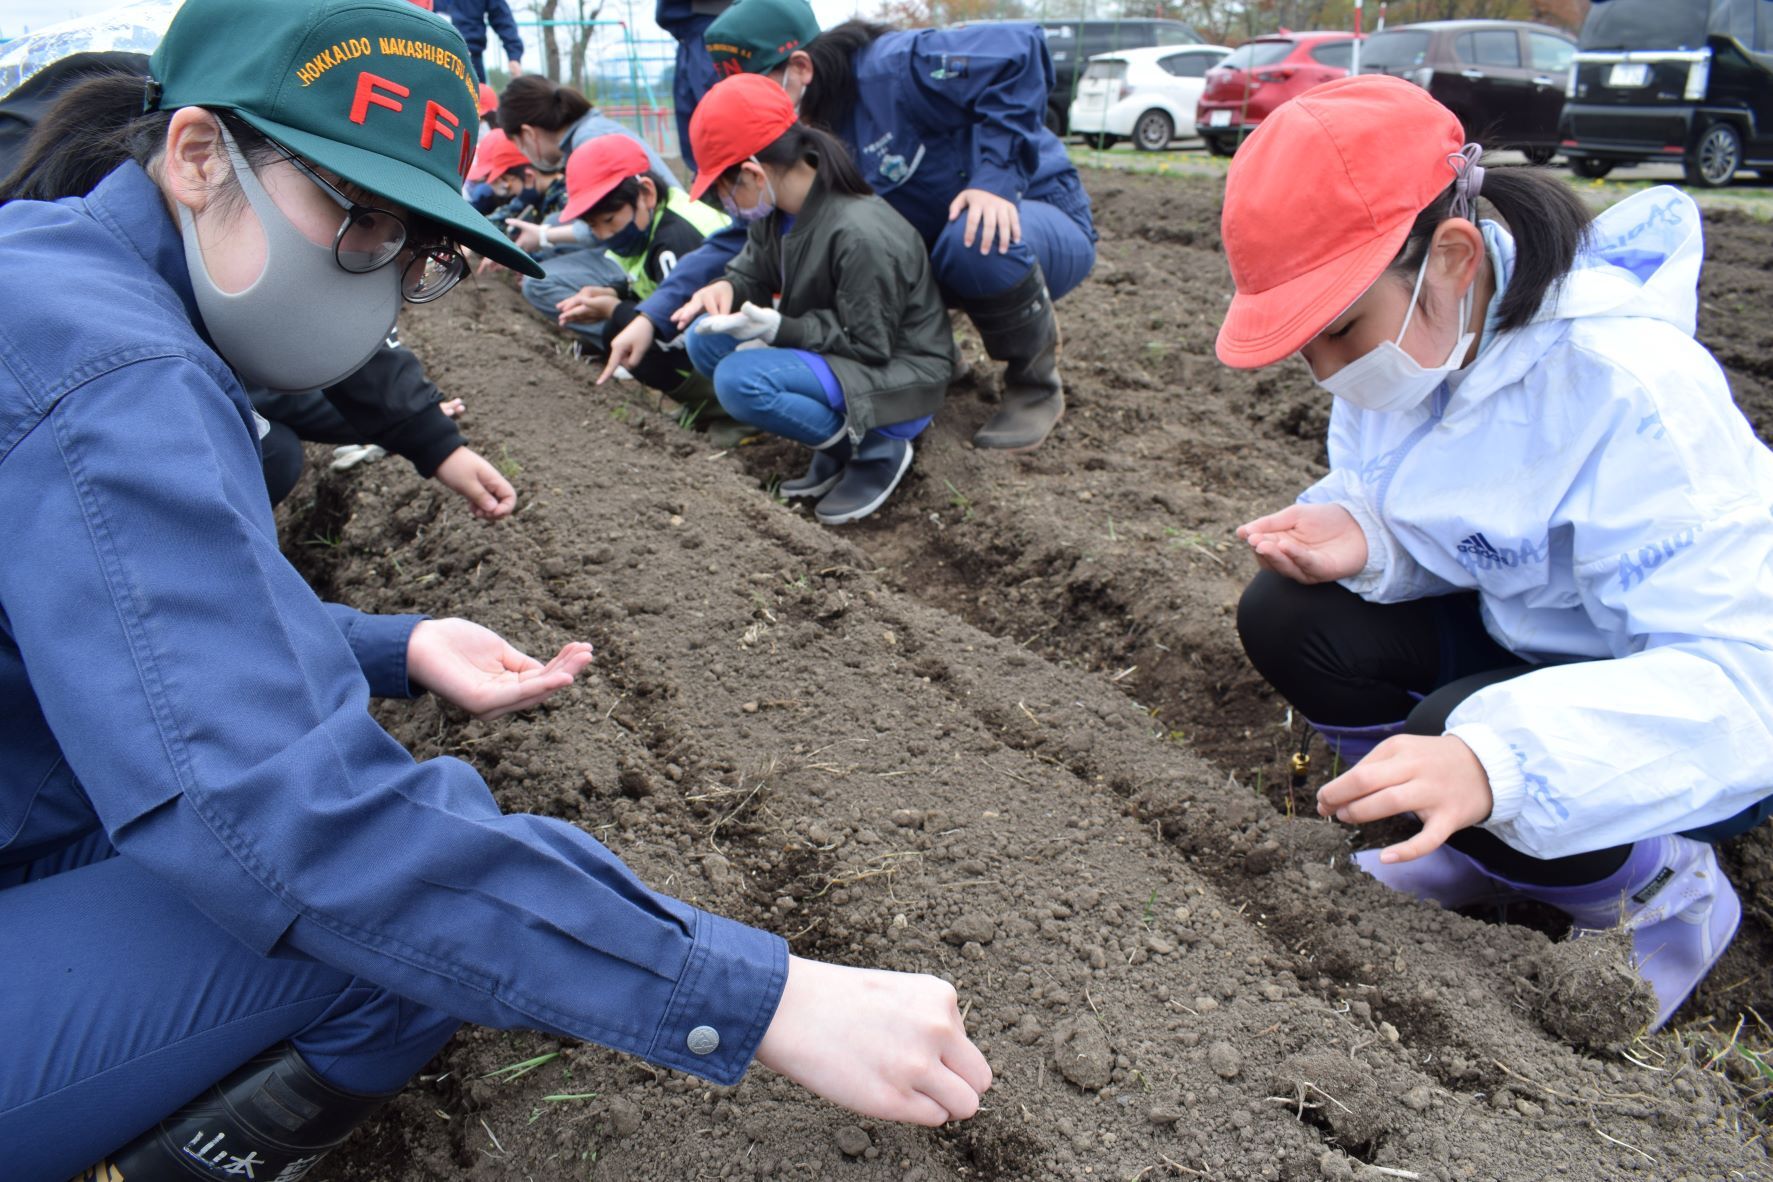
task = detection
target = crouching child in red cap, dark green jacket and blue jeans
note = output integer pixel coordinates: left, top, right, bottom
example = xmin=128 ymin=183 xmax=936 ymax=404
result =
xmin=672 ymin=74 xmax=957 ymax=525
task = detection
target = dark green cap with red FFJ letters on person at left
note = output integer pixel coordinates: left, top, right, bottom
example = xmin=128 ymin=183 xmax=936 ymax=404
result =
xmin=149 ymin=0 xmax=543 ymax=276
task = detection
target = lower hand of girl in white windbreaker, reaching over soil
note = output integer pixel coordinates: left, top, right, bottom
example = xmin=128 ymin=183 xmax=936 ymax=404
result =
xmin=1317 ymin=735 xmax=1495 ymax=863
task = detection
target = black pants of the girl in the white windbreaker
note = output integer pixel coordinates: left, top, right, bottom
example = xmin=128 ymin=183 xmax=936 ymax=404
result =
xmin=1238 ymin=571 xmax=1631 ymax=886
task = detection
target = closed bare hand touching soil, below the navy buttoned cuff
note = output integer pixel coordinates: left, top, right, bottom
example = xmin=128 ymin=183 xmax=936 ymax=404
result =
xmin=757 ymin=957 xmax=991 ymax=1125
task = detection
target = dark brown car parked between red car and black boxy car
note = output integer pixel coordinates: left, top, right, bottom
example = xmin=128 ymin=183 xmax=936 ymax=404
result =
xmin=1360 ymin=21 xmax=1576 ymax=165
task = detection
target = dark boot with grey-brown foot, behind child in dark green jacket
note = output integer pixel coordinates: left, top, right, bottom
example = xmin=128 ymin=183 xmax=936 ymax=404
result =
xmin=965 ymin=262 xmax=1066 ymax=452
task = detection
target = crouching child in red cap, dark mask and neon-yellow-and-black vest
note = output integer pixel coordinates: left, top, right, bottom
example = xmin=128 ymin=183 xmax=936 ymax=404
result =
xmin=557 ymin=135 xmax=729 ymax=406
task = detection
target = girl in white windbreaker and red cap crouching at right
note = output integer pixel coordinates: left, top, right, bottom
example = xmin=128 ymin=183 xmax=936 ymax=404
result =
xmin=1218 ymin=76 xmax=1773 ymax=1026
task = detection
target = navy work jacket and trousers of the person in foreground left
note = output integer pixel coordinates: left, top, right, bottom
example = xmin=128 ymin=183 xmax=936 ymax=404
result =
xmin=0 ymin=163 xmax=787 ymax=1178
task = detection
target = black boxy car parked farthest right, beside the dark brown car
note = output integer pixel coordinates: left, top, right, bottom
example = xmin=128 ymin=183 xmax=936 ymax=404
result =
xmin=1558 ymin=0 xmax=1773 ymax=188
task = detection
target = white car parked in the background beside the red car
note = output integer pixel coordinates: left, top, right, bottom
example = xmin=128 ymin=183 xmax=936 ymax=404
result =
xmin=1071 ymin=44 xmax=1230 ymax=152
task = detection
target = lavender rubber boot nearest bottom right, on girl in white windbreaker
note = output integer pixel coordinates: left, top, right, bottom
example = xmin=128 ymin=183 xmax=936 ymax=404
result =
xmin=1502 ymin=836 xmax=1743 ymax=1030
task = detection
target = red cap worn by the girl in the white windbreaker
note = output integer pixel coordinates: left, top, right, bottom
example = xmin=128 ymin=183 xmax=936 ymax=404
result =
xmin=1219 ymin=74 xmax=1464 ymax=369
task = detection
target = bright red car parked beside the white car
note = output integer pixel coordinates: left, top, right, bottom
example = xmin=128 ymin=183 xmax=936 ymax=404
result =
xmin=1195 ymin=32 xmax=1355 ymax=156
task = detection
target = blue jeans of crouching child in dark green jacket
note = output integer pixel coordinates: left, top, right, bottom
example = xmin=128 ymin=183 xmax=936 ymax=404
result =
xmin=683 ymin=319 xmax=929 ymax=447
